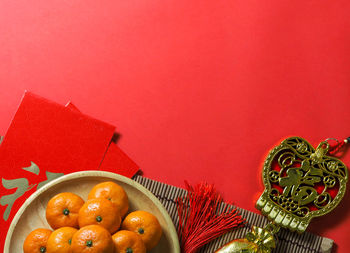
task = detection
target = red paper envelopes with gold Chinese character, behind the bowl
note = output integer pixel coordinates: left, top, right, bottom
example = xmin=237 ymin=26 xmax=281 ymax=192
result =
xmin=0 ymin=92 xmax=139 ymax=249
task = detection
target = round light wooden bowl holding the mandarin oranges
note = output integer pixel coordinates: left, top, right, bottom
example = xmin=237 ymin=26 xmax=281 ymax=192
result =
xmin=4 ymin=171 xmax=180 ymax=253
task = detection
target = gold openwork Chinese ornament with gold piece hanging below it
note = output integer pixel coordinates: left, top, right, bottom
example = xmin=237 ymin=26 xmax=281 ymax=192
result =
xmin=216 ymin=137 xmax=348 ymax=253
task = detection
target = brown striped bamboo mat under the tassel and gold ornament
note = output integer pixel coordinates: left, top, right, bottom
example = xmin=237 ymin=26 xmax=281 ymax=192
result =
xmin=133 ymin=175 xmax=333 ymax=253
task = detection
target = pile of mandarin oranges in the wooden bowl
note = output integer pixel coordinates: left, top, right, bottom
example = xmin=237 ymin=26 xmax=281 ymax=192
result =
xmin=23 ymin=182 xmax=162 ymax=253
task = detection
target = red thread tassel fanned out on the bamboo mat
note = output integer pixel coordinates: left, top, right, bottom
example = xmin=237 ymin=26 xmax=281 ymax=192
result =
xmin=177 ymin=182 xmax=245 ymax=253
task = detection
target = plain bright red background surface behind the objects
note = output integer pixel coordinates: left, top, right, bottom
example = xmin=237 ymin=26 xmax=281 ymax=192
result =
xmin=0 ymin=0 xmax=350 ymax=252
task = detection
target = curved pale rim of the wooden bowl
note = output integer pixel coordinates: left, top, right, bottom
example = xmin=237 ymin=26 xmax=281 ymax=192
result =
xmin=4 ymin=170 xmax=180 ymax=253
